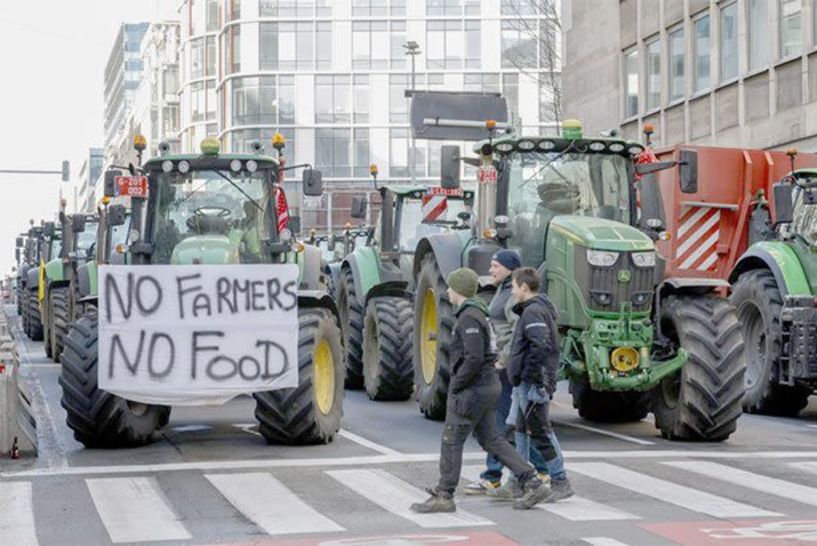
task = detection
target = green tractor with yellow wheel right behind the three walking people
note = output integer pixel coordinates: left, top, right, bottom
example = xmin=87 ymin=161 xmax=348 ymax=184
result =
xmin=413 ymin=121 xmax=745 ymax=441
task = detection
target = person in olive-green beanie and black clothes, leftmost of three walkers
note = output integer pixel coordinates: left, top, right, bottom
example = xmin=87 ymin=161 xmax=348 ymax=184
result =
xmin=411 ymin=268 xmax=549 ymax=514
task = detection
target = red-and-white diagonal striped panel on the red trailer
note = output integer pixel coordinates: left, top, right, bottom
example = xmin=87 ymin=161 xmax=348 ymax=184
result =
xmin=675 ymin=207 xmax=721 ymax=271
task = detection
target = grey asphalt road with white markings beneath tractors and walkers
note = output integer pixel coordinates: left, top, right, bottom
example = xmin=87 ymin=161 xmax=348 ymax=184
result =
xmin=0 ymin=306 xmax=817 ymax=546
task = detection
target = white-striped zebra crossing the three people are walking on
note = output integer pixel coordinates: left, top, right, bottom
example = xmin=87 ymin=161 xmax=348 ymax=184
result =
xmin=0 ymin=460 xmax=817 ymax=546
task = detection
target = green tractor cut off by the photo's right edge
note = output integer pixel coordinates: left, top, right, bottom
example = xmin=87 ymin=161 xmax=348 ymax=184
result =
xmin=730 ymin=166 xmax=817 ymax=416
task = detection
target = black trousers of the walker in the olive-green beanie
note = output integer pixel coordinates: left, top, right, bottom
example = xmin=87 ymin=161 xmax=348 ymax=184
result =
xmin=437 ymin=382 xmax=536 ymax=493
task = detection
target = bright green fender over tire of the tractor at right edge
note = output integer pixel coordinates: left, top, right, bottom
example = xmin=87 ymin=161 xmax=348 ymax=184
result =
xmin=729 ymin=241 xmax=811 ymax=296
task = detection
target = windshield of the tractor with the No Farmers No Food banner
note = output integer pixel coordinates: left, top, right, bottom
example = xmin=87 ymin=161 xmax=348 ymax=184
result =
xmin=152 ymin=170 xmax=273 ymax=263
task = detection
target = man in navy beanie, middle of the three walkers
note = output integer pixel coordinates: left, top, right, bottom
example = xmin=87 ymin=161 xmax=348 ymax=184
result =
xmin=465 ymin=249 xmax=548 ymax=498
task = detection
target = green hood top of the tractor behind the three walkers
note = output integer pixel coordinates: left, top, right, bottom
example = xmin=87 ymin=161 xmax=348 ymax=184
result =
xmin=550 ymin=216 xmax=655 ymax=252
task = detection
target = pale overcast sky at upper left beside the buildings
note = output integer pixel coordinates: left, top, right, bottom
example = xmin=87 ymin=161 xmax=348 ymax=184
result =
xmin=0 ymin=0 xmax=167 ymax=276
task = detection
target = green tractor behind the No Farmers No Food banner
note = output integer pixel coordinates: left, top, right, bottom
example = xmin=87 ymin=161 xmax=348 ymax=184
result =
xmin=60 ymin=139 xmax=344 ymax=447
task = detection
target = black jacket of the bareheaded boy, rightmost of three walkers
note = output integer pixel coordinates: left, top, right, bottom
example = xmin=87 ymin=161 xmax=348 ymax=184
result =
xmin=508 ymin=294 xmax=559 ymax=395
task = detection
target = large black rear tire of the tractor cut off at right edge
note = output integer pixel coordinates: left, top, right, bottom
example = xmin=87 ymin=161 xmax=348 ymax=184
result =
xmin=729 ymin=269 xmax=811 ymax=416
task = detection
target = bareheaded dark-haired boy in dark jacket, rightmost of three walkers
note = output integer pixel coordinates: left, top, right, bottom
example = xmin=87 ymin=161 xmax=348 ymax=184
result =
xmin=508 ymin=267 xmax=573 ymax=502
